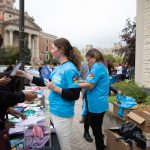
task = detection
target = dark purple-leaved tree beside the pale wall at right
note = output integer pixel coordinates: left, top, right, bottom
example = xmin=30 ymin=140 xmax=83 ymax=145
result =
xmin=114 ymin=18 xmax=136 ymax=66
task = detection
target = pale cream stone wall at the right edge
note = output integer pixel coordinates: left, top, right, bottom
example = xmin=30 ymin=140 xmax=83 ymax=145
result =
xmin=135 ymin=0 xmax=150 ymax=89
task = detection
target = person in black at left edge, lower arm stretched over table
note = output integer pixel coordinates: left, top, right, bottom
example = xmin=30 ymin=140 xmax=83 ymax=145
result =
xmin=0 ymin=90 xmax=36 ymax=150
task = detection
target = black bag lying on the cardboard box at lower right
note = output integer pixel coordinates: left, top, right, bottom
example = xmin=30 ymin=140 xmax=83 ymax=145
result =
xmin=119 ymin=122 xmax=146 ymax=149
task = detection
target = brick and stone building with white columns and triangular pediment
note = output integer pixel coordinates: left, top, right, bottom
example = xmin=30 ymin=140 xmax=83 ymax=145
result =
xmin=0 ymin=0 xmax=57 ymax=65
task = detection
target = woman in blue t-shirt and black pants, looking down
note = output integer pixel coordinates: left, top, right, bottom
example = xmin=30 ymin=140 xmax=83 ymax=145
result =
xmin=80 ymin=48 xmax=109 ymax=150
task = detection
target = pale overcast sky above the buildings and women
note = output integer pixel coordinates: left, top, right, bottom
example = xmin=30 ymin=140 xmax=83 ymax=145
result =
xmin=15 ymin=0 xmax=136 ymax=49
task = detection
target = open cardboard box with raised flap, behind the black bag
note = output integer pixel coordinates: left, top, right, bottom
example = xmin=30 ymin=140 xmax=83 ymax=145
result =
xmin=126 ymin=110 xmax=150 ymax=133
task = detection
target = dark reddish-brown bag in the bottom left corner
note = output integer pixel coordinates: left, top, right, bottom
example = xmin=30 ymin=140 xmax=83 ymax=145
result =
xmin=0 ymin=129 xmax=11 ymax=150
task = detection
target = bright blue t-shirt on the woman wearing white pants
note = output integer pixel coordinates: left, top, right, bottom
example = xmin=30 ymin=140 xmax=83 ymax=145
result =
xmin=49 ymin=61 xmax=79 ymax=118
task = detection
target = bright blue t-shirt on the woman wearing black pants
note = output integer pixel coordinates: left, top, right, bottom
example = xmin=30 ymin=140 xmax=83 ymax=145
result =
xmin=87 ymin=63 xmax=109 ymax=113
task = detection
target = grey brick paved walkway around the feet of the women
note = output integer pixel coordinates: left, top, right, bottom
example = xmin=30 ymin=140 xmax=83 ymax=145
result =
xmin=71 ymin=96 xmax=120 ymax=150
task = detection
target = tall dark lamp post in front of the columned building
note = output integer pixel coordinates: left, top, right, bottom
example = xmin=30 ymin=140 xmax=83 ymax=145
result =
xmin=19 ymin=0 xmax=24 ymax=90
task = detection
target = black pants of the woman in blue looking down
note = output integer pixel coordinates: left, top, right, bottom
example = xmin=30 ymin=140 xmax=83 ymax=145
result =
xmin=86 ymin=112 xmax=105 ymax=150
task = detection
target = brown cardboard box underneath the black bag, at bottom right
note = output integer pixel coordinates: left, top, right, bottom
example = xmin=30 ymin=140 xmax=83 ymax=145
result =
xmin=107 ymin=129 xmax=150 ymax=150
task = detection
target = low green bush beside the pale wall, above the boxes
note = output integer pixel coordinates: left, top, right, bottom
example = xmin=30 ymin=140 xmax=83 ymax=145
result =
xmin=114 ymin=81 xmax=147 ymax=103
